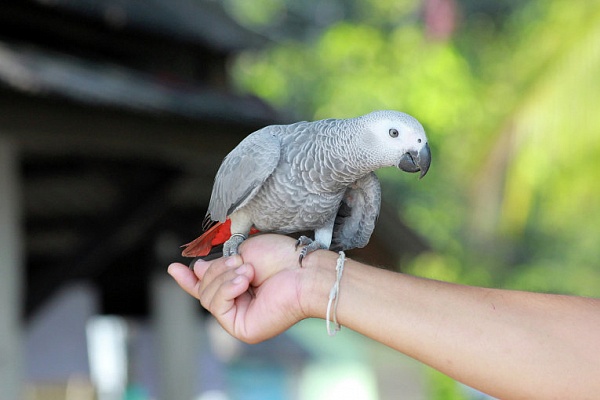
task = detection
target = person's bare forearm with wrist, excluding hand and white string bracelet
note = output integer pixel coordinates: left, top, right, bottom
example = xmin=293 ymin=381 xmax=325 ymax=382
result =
xmin=307 ymin=252 xmax=600 ymax=398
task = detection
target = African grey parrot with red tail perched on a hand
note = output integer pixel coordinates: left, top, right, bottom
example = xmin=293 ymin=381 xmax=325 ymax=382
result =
xmin=183 ymin=111 xmax=431 ymax=261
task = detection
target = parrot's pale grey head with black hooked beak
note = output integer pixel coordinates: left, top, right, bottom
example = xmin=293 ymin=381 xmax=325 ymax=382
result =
xmin=361 ymin=111 xmax=431 ymax=178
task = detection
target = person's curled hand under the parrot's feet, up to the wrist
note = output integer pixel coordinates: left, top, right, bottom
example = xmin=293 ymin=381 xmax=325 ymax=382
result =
xmin=168 ymin=234 xmax=310 ymax=343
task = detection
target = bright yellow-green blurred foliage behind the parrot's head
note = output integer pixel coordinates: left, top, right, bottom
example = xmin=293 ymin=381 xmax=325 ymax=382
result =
xmin=230 ymin=0 xmax=600 ymax=296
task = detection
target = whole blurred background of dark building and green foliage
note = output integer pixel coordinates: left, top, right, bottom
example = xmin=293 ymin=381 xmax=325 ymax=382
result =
xmin=0 ymin=0 xmax=600 ymax=400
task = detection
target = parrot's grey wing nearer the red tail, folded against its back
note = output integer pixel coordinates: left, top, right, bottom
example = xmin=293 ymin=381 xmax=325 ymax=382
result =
xmin=207 ymin=126 xmax=281 ymax=222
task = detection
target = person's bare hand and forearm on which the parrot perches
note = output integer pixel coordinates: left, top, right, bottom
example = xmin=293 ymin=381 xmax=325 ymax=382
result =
xmin=168 ymin=234 xmax=600 ymax=399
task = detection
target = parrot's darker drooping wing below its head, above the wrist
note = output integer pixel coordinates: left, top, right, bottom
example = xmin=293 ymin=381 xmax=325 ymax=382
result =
xmin=331 ymin=172 xmax=381 ymax=250
